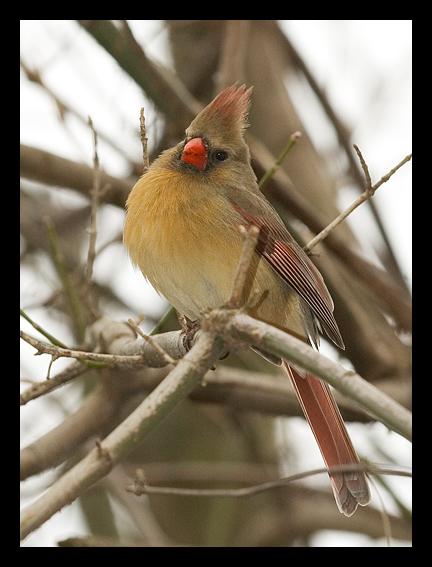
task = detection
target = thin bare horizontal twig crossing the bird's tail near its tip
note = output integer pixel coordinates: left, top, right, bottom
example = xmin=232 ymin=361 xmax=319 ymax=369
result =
xmin=126 ymin=463 xmax=412 ymax=498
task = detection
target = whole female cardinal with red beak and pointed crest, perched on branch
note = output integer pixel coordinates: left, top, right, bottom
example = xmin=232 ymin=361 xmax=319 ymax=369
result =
xmin=124 ymin=85 xmax=369 ymax=516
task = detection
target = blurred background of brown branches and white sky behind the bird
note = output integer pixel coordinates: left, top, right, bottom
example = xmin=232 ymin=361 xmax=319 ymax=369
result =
xmin=21 ymin=20 xmax=412 ymax=547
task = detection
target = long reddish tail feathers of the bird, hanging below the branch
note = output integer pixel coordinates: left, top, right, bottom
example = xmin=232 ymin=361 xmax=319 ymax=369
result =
xmin=284 ymin=361 xmax=370 ymax=516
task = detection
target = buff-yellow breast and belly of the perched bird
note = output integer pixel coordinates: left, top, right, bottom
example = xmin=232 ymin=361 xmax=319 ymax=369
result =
xmin=124 ymin=178 xmax=307 ymax=334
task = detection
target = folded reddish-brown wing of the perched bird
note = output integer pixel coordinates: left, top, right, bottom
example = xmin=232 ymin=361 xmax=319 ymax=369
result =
xmin=231 ymin=202 xmax=345 ymax=348
